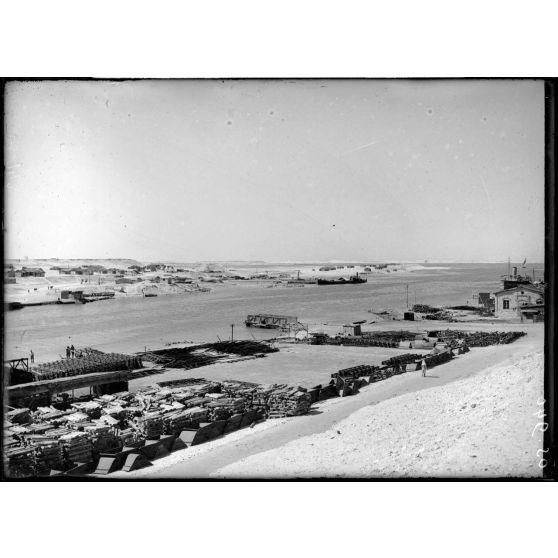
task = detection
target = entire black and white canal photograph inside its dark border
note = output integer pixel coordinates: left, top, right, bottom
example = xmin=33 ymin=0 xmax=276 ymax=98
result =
xmin=2 ymin=78 xmax=549 ymax=482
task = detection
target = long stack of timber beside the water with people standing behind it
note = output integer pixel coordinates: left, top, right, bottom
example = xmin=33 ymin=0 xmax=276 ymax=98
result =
xmin=29 ymin=351 xmax=143 ymax=381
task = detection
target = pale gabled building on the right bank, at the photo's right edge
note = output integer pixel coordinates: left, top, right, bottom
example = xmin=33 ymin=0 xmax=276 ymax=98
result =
xmin=494 ymin=285 xmax=544 ymax=321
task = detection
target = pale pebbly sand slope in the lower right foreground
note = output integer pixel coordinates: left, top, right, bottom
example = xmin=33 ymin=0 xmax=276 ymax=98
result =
xmin=213 ymin=351 xmax=543 ymax=478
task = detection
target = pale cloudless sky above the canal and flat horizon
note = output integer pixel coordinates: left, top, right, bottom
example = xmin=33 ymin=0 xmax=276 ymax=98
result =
xmin=4 ymin=80 xmax=544 ymax=262
